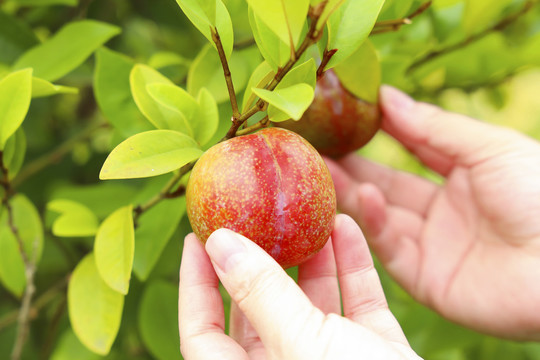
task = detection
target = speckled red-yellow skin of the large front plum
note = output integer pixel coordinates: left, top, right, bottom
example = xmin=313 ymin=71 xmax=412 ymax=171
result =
xmin=186 ymin=128 xmax=336 ymax=268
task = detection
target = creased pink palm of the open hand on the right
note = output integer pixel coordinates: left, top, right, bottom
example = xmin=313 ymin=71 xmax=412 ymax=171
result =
xmin=418 ymin=147 xmax=540 ymax=333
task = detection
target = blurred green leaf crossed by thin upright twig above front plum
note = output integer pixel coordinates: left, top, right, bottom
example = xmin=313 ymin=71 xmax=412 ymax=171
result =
xmin=187 ymin=46 xmax=251 ymax=104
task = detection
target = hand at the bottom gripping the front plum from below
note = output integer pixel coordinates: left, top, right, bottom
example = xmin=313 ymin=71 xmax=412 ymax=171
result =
xmin=179 ymin=215 xmax=418 ymax=360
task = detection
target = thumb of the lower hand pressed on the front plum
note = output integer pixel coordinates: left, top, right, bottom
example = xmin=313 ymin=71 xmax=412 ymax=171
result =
xmin=206 ymin=229 xmax=324 ymax=358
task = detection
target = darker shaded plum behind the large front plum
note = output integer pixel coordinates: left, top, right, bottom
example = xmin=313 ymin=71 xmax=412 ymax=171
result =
xmin=275 ymin=70 xmax=381 ymax=158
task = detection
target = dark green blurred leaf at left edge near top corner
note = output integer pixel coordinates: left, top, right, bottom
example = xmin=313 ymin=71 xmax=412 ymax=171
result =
xmin=0 ymin=11 xmax=38 ymax=64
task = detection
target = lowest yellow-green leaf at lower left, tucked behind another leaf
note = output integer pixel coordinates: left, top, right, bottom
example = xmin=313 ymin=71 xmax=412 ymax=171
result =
xmin=68 ymin=254 xmax=124 ymax=355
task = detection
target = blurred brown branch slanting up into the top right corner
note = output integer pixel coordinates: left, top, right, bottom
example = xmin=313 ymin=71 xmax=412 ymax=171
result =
xmin=407 ymin=0 xmax=535 ymax=73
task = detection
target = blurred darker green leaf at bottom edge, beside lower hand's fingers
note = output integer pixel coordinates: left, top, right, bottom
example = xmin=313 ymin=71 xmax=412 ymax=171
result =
xmin=139 ymin=280 xmax=182 ymax=360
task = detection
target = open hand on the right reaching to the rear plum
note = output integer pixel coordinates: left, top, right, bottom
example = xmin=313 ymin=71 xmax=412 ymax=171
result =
xmin=327 ymin=87 xmax=540 ymax=340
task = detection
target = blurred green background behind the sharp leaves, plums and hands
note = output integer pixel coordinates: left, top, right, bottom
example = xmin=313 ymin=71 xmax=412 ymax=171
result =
xmin=0 ymin=0 xmax=540 ymax=360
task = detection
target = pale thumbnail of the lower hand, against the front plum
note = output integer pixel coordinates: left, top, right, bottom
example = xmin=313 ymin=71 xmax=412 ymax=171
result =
xmin=206 ymin=229 xmax=247 ymax=273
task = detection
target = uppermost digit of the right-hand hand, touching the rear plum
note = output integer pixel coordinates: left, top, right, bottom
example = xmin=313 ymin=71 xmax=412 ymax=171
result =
xmin=380 ymin=86 xmax=511 ymax=174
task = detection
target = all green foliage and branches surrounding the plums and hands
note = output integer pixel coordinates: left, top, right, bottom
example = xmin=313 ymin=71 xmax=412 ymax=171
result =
xmin=0 ymin=0 xmax=540 ymax=359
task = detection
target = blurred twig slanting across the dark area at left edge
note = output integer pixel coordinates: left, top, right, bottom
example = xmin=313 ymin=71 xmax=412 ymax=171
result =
xmin=12 ymin=123 xmax=109 ymax=187
